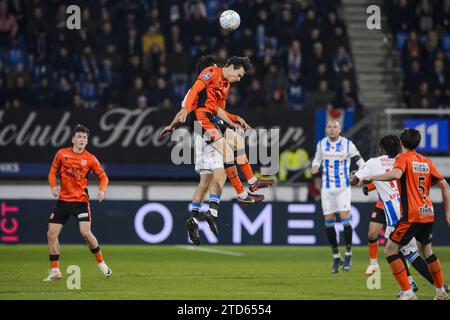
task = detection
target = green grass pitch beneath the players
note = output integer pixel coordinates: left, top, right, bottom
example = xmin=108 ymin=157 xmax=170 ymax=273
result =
xmin=0 ymin=244 xmax=450 ymax=300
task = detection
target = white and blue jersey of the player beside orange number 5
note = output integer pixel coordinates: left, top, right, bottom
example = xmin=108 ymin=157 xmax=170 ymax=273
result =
xmin=355 ymin=155 xmax=401 ymax=226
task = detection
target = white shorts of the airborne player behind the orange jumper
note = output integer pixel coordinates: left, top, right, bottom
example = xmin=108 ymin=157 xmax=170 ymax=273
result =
xmin=194 ymin=134 xmax=223 ymax=174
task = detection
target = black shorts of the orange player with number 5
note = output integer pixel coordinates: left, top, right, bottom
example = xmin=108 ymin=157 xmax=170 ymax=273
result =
xmin=389 ymin=220 xmax=433 ymax=246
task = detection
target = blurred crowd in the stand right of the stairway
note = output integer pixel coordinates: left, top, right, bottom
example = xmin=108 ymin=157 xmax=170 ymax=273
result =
xmin=384 ymin=0 xmax=450 ymax=109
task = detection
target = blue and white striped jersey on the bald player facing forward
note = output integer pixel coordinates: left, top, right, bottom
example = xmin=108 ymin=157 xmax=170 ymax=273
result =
xmin=312 ymin=137 xmax=364 ymax=189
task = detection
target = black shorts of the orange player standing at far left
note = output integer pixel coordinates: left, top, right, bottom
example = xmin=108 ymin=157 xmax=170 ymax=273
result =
xmin=49 ymin=200 xmax=91 ymax=225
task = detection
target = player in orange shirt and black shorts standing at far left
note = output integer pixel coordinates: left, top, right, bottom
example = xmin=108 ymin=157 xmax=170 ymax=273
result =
xmin=44 ymin=125 xmax=112 ymax=281
